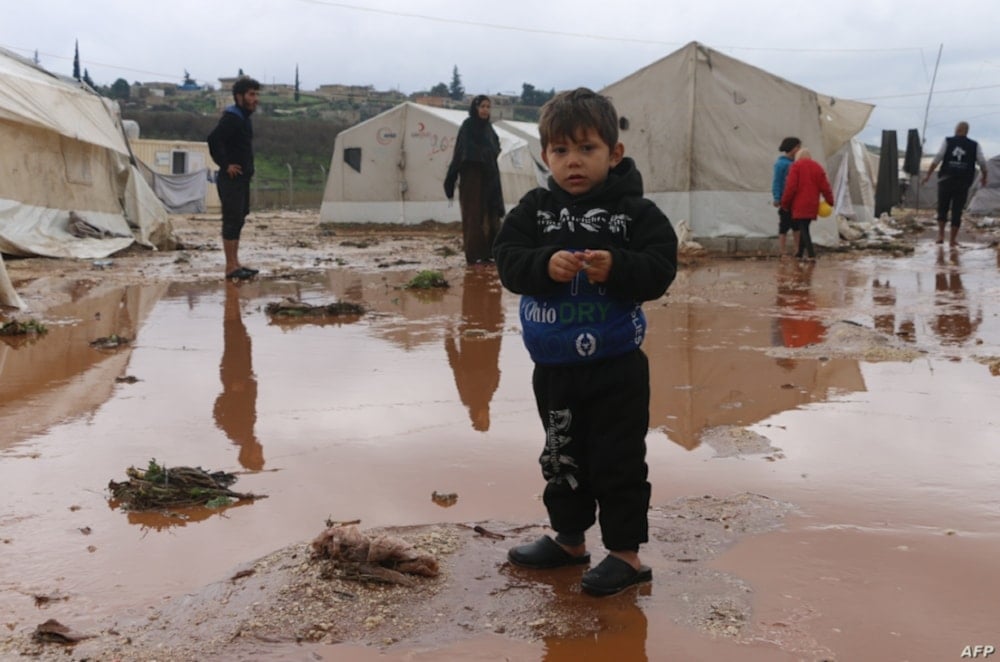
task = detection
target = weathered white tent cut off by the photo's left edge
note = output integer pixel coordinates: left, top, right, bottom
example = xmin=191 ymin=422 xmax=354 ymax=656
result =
xmin=0 ymin=49 xmax=173 ymax=307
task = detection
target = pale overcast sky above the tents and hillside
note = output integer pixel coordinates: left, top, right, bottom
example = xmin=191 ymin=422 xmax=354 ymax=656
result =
xmin=7 ymin=0 xmax=1000 ymax=157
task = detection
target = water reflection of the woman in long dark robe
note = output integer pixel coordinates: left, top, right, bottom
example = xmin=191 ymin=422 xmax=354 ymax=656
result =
xmin=444 ymin=269 xmax=504 ymax=432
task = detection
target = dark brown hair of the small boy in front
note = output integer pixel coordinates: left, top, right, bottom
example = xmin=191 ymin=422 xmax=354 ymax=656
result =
xmin=538 ymin=87 xmax=618 ymax=149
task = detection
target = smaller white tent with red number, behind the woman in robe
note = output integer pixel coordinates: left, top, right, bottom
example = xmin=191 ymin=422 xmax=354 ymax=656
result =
xmin=320 ymin=101 xmax=538 ymax=224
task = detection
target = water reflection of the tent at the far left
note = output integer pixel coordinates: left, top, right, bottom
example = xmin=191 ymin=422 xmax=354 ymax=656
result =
xmin=0 ymin=285 xmax=166 ymax=447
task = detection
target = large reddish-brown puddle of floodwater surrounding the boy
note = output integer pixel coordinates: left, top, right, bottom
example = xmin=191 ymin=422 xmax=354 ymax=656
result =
xmin=0 ymin=245 xmax=1000 ymax=662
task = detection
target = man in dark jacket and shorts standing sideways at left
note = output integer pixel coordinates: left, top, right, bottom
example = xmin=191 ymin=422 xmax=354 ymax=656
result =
xmin=208 ymin=76 xmax=260 ymax=280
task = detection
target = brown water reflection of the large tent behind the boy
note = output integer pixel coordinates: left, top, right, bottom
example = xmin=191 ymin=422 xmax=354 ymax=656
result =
xmin=643 ymin=302 xmax=865 ymax=449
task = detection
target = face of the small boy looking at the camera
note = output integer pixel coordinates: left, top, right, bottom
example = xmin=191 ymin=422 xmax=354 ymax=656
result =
xmin=542 ymin=128 xmax=625 ymax=195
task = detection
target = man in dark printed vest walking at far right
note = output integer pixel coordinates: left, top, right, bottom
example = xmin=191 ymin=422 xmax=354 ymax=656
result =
xmin=924 ymin=122 xmax=986 ymax=246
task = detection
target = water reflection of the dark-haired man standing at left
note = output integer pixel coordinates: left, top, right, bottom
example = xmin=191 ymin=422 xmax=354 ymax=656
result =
xmin=213 ymin=282 xmax=264 ymax=471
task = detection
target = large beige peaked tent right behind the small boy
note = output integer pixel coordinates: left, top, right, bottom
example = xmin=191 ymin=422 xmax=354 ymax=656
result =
xmin=602 ymin=42 xmax=873 ymax=245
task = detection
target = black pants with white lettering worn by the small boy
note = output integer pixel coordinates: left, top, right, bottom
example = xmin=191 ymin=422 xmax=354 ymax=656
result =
xmin=532 ymin=350 xmax=650 ymax=551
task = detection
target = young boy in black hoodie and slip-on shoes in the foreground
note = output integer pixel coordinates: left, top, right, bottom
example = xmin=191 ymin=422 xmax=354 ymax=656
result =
xmin=494 ymin=88 xmax=677 ymax=595
